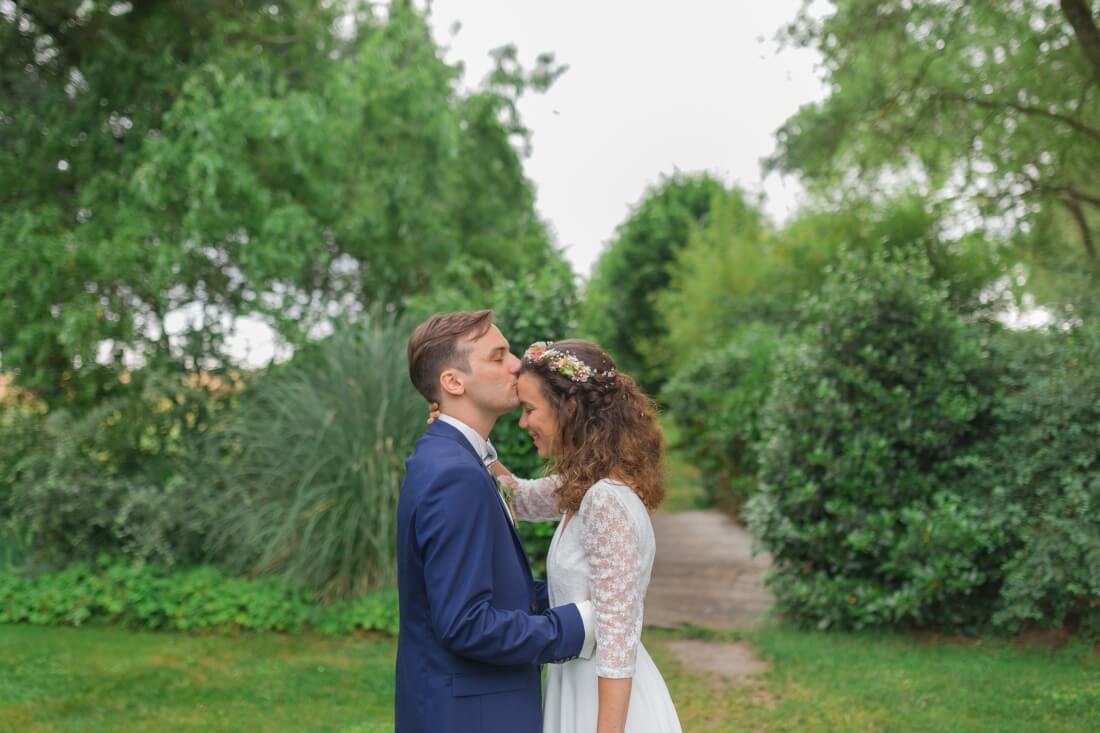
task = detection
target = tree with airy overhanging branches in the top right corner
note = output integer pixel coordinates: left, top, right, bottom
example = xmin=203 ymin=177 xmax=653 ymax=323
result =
xmin=770 ymin=0 xmax=1100 ymax=290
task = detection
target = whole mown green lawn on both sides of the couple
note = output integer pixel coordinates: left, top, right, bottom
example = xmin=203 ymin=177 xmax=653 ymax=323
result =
xmin=0 ymin=626 xmax=1100 ymax=733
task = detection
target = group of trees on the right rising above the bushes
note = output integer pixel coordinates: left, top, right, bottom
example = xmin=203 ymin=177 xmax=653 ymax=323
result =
xmin=582 ymin=0 xmax=1100 ymax=390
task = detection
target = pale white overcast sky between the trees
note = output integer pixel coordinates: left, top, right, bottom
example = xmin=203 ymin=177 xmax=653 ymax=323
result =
xmin=420 ymin=0 xmax=824 ymax=276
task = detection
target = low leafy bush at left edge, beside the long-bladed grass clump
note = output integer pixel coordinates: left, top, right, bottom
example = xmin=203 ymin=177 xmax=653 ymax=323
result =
xmin=0 ymin=372 xmax=237 ymax=567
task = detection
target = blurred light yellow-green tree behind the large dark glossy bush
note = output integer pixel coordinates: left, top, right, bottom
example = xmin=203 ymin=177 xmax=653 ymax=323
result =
xmin=648 ymin=189 xmax=999 ymax=373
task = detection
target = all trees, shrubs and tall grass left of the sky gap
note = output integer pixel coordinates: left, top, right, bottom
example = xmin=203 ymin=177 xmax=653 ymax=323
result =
xmin=0 ymin=0 xmax=576 ymax=600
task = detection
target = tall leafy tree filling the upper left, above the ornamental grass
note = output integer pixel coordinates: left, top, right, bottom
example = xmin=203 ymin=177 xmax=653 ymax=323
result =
xmin=0 ymin=0 xmax=557 ymax=404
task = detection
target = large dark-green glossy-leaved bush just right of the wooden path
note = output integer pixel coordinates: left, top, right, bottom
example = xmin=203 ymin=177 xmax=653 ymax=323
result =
xmin=747 ymin=249 xmax=1016 ymax=628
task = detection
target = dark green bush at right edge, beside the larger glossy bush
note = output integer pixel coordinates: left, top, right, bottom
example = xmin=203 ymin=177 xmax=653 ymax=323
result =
xmin=990 ymin=321 xmax=1100 ymax=636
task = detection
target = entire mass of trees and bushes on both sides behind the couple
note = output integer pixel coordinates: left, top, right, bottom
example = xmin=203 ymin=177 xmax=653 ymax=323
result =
xmin=0 ymin=0 xmax=1100 ymax=632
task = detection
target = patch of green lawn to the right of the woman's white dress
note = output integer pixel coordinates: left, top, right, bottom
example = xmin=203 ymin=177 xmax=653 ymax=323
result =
xmin=647 ymin=627 xmax=1100 ymax=733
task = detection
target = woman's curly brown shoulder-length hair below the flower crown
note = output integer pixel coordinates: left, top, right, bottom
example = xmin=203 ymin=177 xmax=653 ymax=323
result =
xmin=520 ymin=339 xmax=664 ymax=512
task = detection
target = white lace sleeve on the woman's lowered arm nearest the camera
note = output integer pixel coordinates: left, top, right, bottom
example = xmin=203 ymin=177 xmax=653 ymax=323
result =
xmin=578 ymin=484 xmax=642 ymax=678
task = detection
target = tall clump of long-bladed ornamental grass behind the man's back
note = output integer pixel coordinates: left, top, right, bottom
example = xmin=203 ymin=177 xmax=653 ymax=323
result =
xmin=207 ymin=314 xmax=425 ymax=599
